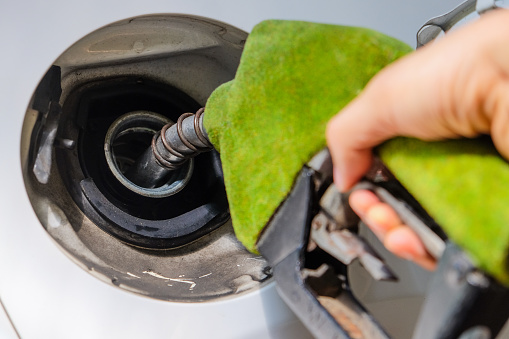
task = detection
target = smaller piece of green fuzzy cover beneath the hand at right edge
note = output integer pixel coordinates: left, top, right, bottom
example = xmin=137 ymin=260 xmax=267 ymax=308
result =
xmin=378 ymin=137 xmax=509 ymax=286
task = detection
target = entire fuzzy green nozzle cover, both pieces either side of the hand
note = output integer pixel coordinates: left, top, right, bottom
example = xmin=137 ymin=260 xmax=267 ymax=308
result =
xmin=204 ymin=21 xmax=509 ymax=284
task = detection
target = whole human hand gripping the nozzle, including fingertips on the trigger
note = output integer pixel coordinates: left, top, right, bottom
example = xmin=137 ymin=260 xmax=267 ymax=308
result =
xmin=327 ymin=10 xmax=509 ymax=268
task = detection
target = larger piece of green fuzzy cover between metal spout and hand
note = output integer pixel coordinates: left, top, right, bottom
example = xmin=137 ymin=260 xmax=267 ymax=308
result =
xmin=204 ymin=21 xmax=411 ymax=252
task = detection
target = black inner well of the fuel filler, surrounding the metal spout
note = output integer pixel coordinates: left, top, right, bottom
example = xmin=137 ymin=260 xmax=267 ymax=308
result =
xmin=64 ymin=77 xmax=229 ymax=249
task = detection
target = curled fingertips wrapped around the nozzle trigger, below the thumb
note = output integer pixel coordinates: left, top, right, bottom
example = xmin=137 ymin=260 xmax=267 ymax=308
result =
xmin=350 ymin=190 xmax=436 ymax=270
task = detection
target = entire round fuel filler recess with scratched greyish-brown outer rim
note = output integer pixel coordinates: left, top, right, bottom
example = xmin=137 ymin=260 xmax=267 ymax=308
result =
xmin=21 ymin=14 xmax=271 ymax=302
